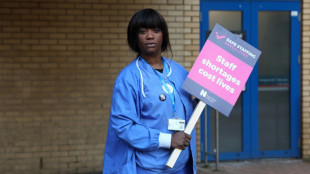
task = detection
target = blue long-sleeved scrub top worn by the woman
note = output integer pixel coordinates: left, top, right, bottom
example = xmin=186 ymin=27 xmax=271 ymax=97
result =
xmin=103 ymin=58 xmax=196 ymax=173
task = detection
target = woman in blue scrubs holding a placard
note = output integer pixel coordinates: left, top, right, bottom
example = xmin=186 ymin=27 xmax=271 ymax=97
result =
xmin=103 ymin=9 xmax=196 ymax=174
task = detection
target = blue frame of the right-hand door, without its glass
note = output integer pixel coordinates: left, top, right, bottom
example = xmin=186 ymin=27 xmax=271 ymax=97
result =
xmin=251 ymin=2 xmax=300 ymax=158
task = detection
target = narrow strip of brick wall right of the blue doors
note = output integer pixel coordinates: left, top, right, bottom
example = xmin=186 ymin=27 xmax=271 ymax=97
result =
xmin=301 ymin=0 xmax=310 ymax=159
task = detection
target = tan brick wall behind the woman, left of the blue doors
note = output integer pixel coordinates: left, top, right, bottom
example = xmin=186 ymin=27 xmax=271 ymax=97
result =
xmin=0 ymin=0 xmax=200 ymax=174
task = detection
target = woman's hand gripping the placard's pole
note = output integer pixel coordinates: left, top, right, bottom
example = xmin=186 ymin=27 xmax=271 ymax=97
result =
xmin=171 ymin=132 xmax=192 ymax=150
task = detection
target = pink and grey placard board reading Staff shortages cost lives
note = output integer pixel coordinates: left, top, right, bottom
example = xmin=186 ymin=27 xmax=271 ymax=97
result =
xmin=182 ymin=24 xmax=261 ymax=116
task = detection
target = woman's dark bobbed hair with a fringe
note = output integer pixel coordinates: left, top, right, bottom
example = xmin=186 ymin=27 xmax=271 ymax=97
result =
xmin=127 ymin=9 xmax=171 ymax=54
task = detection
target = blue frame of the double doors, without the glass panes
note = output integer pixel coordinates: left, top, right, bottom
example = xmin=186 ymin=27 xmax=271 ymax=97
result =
xmin=200 ymin=0 xmax=301 ymax=161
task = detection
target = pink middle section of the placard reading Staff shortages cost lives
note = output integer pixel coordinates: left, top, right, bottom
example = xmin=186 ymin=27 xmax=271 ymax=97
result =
xmin=188 ymin=40 xmax=253 ymax=105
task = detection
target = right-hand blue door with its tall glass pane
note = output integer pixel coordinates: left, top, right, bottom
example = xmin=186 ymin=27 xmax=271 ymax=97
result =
xmin=252 ymin=2 xmax=300 ymax=158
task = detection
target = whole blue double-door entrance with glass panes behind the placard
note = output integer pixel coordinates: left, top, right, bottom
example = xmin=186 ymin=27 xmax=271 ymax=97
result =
xmin=200 ymin=0 xmax=300 ymax=161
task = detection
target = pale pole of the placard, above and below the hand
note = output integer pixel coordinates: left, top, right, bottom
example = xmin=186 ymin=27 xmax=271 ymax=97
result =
xmin=166 ymin=101 xmax=206 ymax=168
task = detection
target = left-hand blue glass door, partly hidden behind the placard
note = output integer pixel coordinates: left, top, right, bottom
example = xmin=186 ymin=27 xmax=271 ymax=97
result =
xmin=201 ymin=1 xmax=250 ymax=160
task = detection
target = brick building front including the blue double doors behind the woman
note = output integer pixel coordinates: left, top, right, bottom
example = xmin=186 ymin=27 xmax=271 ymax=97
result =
xmin=0 ymin=0 xmax=310 ymax=173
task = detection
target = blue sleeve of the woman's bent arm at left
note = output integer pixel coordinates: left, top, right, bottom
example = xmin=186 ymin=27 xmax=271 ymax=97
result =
xmin=111 ymin=82 xmax=160 ymax=151
